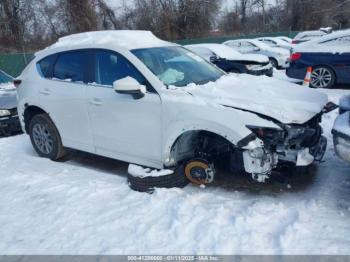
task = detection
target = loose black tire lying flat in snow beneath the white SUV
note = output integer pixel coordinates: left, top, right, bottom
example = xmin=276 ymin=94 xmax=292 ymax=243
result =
xmin=127 ymin=168 xmax=189 ymax=193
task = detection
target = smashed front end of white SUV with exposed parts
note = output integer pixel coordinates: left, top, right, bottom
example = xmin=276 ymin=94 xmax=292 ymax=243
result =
xmin=243 ymin=113 xmax=327 ymax=178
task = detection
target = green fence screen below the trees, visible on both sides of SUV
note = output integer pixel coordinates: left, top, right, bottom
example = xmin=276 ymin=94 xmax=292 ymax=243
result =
xmin=0 ymin=31 xmax=298 ymax=77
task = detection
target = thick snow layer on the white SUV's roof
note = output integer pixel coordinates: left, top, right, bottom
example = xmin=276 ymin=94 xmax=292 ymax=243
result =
xmin=40 ymin=30 xmax=174 ymax=53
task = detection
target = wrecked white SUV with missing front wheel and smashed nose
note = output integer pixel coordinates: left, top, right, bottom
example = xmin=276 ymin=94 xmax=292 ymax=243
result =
xmin=17 ymin=31 xmax=328 ymax=184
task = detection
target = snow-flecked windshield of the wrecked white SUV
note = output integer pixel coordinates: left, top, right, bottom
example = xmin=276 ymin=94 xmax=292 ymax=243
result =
xmin=131 ymin=46 xmax=224 ymax=87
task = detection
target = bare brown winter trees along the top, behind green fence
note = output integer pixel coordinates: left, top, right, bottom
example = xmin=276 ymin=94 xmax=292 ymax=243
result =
xmin=0 ymin=0 xmax=350 ymax=52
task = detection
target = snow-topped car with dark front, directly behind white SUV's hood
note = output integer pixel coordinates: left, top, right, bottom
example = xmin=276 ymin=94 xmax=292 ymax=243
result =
xmin=185 ymin=44 xmax=273 ymax=76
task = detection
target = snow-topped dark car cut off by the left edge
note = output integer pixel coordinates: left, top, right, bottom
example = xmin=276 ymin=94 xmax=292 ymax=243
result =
xmin=0 ymin=70 xmax=21 ymax=137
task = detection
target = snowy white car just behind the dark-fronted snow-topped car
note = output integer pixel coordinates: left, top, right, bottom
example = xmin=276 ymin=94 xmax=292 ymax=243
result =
xmin=223 ymin=39 xmax=290 ymax=68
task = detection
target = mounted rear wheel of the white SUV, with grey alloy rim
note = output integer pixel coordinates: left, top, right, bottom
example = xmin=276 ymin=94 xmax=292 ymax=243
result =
xmin=29 ymin=114 xmax=66 ymax=161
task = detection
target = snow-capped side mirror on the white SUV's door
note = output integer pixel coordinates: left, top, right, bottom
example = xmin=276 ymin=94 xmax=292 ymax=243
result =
xmin=113 ymin=76 xmax=146 ymax=99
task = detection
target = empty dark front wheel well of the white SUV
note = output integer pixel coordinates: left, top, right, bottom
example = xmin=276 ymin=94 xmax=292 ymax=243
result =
xmin=170 ymin=130 xmax=235 ymax=165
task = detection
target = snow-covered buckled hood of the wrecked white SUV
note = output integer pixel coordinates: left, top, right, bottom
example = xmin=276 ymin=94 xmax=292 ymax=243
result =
xmin=185 ymin=74 xmax=328 ymax=124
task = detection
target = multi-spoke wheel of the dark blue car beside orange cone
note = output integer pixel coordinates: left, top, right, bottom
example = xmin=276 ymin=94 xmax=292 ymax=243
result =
xmin=310 ymin=66 xmax=336 ymax=88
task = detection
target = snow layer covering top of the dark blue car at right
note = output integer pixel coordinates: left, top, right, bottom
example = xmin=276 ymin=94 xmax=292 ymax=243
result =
xmin=294 ymin=29 xmax=350 ymax=53
